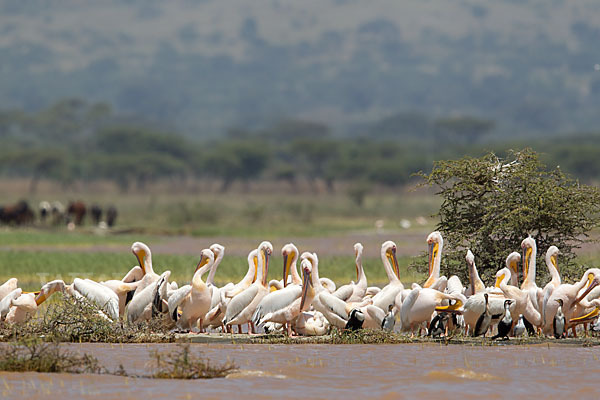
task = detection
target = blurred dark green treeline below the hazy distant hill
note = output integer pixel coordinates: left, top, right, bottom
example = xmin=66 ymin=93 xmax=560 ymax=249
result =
xmin=0 ymin=99 xmax=600 ymax=191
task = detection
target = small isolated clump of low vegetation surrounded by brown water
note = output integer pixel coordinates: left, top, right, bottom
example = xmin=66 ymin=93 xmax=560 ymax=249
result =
xmin=151 ymin=344 xmax=238 ymax=379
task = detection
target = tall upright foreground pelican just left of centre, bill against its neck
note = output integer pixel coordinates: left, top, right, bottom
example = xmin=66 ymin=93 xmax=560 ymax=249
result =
xmin=223 ymin=241 xmax=273 ymax=333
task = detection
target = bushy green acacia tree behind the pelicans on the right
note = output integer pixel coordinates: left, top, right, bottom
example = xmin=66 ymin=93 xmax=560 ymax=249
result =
xmin=421 ymin=149 xmax=600 ymax=279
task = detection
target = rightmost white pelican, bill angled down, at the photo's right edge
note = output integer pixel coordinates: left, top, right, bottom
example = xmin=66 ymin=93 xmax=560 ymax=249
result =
xmin=544 ymin=268 xmax=600 ymax=335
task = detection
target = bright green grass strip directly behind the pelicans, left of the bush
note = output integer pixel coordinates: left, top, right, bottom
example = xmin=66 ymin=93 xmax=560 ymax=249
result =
xmin=0 ymin=250 xmax=424 ymax=290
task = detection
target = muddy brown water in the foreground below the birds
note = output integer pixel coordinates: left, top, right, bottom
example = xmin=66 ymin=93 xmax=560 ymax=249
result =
xmin=0 ymin=344 xmax=600 ymax=400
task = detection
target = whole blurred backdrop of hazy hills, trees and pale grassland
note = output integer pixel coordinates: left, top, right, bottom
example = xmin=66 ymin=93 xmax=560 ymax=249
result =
xmin=0 ymin=0 xmax=600 ymax=288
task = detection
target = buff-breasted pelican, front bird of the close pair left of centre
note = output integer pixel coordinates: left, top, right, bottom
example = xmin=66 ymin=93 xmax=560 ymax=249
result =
xmin=168 ymin=249 xmax=215 ymax=332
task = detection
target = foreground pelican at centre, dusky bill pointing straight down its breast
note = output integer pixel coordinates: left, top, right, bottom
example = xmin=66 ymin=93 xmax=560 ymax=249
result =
xmin=252 ymin=260 xmax=316 ymax=336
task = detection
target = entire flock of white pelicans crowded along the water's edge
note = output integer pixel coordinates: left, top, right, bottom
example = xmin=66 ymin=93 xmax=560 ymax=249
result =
xmin=0 ymin=232 xmax=600 ymax=339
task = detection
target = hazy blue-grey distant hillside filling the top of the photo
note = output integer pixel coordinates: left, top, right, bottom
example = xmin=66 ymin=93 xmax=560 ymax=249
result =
xmin=0 ymin=0 xmax=600 ymax=136
